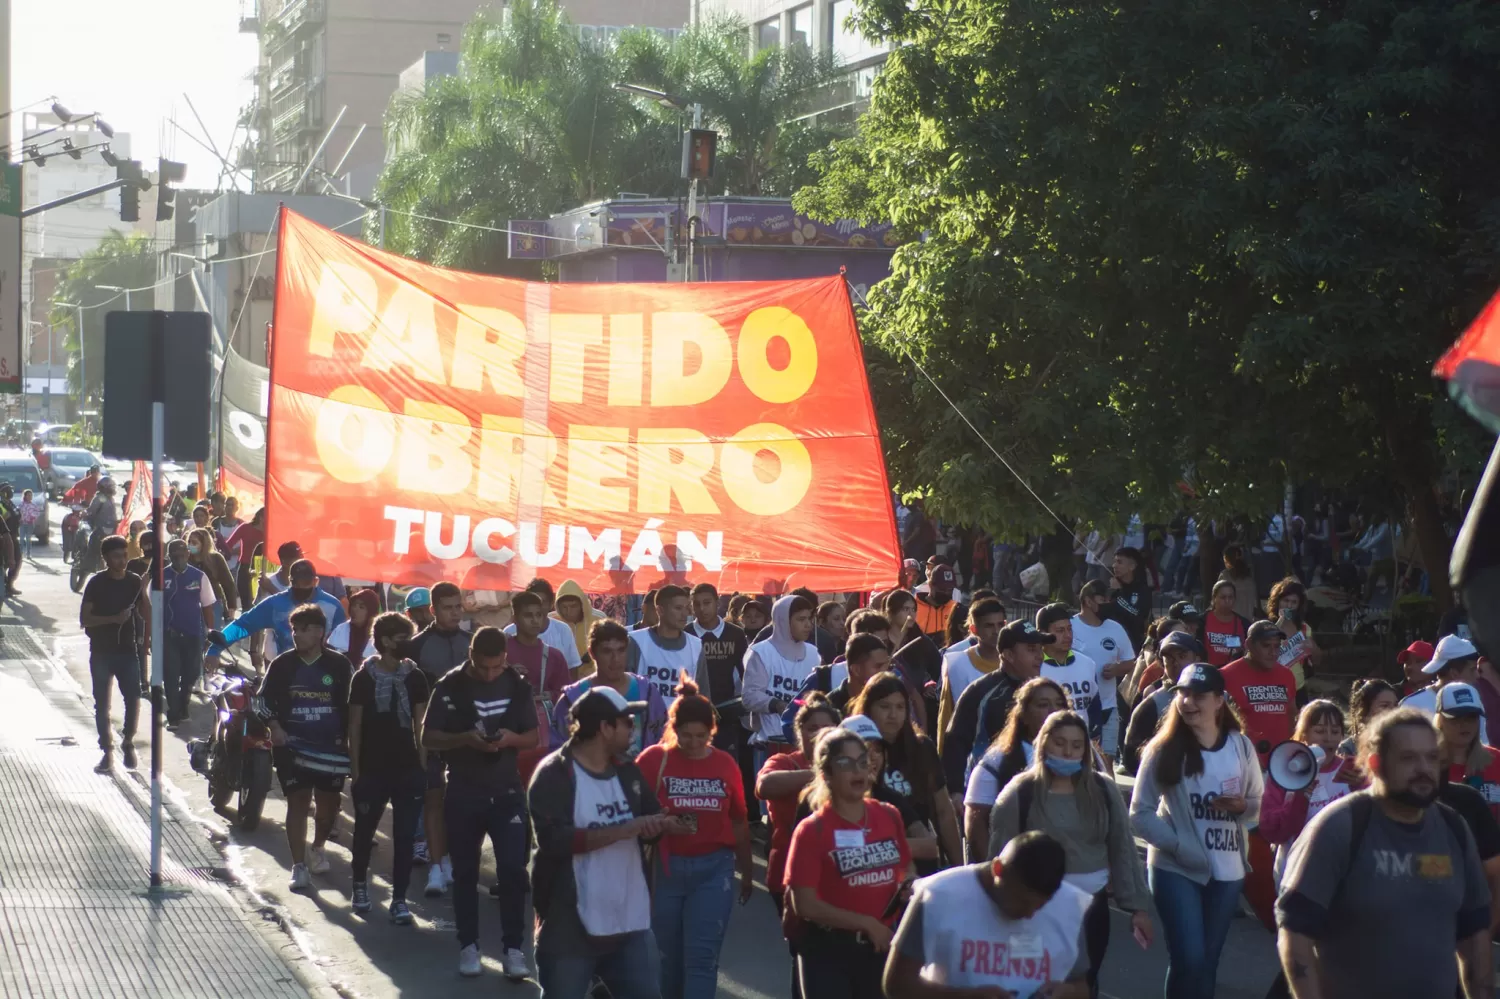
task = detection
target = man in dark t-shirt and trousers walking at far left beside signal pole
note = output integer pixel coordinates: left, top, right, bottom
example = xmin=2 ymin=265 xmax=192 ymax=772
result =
xmin=78 ymin=534 xmax=150 ymax=774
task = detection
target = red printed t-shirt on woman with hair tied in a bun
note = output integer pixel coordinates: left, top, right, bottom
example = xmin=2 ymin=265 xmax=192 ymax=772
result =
xmin=636 ymin=746 xmax=746 ymax=857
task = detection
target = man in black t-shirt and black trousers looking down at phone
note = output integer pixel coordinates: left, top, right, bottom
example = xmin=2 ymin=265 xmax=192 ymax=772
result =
xmin=422 ymin=627 xmax=539 ymax=981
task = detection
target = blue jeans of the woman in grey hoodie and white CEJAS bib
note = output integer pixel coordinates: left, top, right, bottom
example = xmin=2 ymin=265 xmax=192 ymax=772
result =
xmin=1148 ymin=867 xmax=1245 ymax=999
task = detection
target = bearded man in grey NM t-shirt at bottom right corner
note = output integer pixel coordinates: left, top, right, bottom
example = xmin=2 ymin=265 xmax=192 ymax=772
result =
xmin=1277 ymin=708 xmax=1493 ymax=999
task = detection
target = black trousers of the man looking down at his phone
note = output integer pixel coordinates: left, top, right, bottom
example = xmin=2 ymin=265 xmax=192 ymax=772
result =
xmin=443 ymin=782 xmax=530 ymax=951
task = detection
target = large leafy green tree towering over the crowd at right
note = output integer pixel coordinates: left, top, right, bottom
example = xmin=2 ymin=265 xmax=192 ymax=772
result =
xmin=800 ymin=0 xmax=1500 ymax=599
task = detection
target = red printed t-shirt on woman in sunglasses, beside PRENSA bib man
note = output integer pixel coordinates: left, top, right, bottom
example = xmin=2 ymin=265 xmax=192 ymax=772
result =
xmin=786 ymin=798 xmax=912 ymax=923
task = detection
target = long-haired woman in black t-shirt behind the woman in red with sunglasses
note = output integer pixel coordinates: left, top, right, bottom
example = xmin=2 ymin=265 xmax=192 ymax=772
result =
xmin=849 ymin=672 xmax=963 ymax=875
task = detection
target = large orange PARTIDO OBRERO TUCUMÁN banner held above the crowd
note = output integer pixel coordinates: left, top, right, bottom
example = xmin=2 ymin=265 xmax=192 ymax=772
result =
xmin=266 ymin=210 xmax=900 ymax=593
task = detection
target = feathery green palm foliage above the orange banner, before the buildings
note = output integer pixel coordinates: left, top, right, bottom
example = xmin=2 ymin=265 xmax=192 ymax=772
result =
xmin=377 ymin=0 xmax=836 ymax=273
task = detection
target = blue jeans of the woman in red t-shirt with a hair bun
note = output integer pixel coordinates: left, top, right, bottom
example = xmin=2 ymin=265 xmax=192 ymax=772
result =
xmin=651 ymin=848 xmax=735 ymax=999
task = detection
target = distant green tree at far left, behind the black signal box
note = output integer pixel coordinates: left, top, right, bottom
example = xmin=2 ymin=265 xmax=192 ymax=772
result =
xmin=50 ymin=230 xmax=156 ymax=410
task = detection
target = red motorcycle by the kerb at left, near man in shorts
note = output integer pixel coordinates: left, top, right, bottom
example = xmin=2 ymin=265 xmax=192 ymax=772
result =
xmin=188 ymin=666 xmax=272 ymax=833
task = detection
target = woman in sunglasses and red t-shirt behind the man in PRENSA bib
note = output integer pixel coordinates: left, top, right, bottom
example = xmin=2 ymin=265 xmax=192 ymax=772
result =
xmin=786 ymin=729 xmax=915 ymax=999
